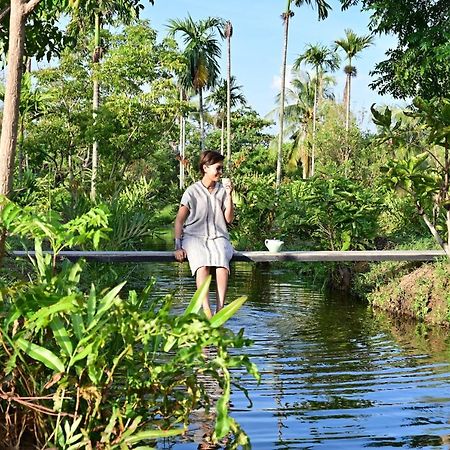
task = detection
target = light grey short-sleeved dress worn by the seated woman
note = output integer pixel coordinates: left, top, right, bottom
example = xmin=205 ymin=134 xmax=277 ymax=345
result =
xmin=180 ymin=181 xmax=234 ymax=275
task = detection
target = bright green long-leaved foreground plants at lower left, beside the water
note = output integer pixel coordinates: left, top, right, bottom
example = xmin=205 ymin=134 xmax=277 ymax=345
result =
xmin=0 ymin=203 xmax=258 ymax=449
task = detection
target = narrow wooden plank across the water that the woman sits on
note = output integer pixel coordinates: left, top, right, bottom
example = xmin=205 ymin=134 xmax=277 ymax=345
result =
xmin=9 ymin=250 xmax=445 ymax=263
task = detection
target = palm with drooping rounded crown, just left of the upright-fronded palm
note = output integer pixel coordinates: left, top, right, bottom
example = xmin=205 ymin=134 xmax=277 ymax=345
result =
xmin=294 ymin=44 xmax=339 ymax=176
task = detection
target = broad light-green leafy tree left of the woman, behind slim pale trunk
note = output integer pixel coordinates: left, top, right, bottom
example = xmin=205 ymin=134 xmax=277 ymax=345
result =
xmin=23 ymin=22 xmax=182 ymax=199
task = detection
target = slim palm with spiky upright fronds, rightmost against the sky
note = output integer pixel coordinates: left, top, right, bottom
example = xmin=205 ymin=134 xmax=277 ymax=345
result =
xmin=334 ymin=29 xmax=373 ymax=132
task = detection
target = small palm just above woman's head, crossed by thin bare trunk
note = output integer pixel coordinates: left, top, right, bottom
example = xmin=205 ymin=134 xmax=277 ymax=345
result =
xmin=207 ymin=77 xmax=247 ymax=155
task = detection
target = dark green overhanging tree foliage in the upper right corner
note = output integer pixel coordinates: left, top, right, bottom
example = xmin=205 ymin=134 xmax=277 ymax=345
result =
xmin=341 ymin=0 xmax=450 ymax=100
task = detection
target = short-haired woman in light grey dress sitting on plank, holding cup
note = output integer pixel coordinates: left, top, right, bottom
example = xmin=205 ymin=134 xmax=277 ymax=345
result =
xmin=175 ymin=151 xmax=234 ymax=318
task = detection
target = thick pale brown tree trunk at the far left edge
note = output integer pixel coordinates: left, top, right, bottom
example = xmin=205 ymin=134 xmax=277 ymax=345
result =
xmin=0 ymin=0 xmax=26 ymax=266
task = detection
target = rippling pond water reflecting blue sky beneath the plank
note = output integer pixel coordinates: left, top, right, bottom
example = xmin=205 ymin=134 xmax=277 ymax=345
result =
xmin=143 ymin=263 xmax=450 ymax=450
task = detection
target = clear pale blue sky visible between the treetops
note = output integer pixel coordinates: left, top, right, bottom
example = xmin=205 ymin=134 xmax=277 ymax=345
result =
xmin=141 ymin=0 xmax=396 ymax=129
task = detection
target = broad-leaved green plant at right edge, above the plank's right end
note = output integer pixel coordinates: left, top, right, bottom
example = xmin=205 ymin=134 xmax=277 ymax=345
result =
xmin=372 ymin=98 xmax=450 ymax=258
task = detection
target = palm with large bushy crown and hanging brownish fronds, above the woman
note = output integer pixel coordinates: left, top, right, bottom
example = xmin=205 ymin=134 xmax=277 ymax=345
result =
xmin=168 ymin=16 xmax=223 ymax=151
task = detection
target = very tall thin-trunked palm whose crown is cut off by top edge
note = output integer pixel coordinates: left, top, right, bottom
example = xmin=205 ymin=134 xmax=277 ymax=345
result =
xmin=276 ymin=0 xmax=331 ymax=187
